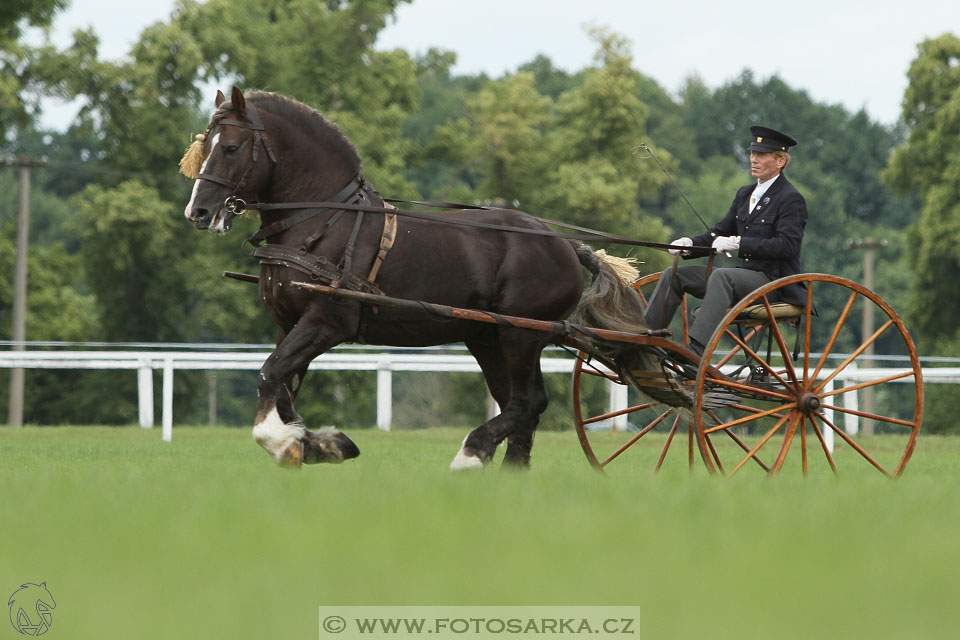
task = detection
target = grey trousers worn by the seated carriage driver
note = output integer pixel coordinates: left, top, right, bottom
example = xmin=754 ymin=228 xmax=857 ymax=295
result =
xmin=644 ymin=266 xmax=770 ymax=345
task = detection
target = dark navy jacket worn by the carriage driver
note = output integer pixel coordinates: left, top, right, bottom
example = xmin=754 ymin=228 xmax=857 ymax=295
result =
xmin=691 ymin=174 xmax=807 ymax=306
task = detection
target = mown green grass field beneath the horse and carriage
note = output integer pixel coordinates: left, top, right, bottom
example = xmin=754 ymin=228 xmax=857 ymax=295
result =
xmin=0 ymin=427 xmax=960 ymax=639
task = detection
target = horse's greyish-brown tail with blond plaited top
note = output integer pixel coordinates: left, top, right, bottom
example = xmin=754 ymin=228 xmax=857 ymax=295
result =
xmin=571 ymin=241 xmax=647 ymax=333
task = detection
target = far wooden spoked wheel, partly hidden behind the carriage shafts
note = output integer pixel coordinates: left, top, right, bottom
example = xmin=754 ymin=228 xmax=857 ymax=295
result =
xmin=573 ymin=273 xmax=696 ymax=471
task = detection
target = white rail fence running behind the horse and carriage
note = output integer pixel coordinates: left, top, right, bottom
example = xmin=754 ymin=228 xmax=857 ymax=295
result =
xmin=0 ymin=350 xmax=960 ymax=442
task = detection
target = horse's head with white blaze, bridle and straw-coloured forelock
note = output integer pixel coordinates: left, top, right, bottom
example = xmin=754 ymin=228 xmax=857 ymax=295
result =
xmin=180 ymin=87 xmax=276 ymax=233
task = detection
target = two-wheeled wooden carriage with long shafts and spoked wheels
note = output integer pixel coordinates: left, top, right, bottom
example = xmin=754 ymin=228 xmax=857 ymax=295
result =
xmin=290 ymin=258 xmax=923 ymax=476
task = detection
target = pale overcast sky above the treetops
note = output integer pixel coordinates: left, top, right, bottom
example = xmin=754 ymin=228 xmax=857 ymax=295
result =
xmin=28 ymin=0 xmax=960 ymax=128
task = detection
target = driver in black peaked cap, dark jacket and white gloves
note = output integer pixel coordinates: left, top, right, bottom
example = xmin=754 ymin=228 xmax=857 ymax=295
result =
xmin=644 ymin=126 xmax=807 ymax=355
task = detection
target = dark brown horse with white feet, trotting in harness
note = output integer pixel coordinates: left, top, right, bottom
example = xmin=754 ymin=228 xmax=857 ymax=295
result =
xmin=184 ymin=88 xmax=644 ymax=469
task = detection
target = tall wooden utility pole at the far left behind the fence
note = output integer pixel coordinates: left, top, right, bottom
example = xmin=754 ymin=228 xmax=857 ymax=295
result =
xmin=0 ymin=154 xmax=46 ymax=427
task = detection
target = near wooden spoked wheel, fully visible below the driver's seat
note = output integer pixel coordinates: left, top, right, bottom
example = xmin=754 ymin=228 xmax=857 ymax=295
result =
xmin=694 ymin=274 xmax=923 ymax=476
